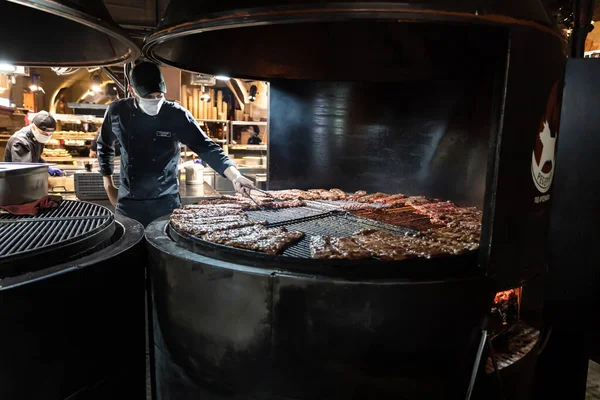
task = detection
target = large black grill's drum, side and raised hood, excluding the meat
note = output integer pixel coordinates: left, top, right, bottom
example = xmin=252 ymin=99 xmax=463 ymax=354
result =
xmin=144 ymin=0 xmax=567 ymax=400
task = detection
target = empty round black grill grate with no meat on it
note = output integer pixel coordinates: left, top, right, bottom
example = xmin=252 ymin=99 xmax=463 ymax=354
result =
xmin=0 ymin=201 xmax=114 ymax=272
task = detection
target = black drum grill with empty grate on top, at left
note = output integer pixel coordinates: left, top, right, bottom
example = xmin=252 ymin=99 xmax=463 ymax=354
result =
xmin=0 ymin=209 xmax=145 ymax=400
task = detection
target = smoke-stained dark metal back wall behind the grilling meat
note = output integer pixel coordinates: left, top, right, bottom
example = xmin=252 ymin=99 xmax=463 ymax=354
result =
xmin=269 ymin=75 xmax=493 ymax=205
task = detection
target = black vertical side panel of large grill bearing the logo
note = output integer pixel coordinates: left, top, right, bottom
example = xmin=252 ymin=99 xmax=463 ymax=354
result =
xmin=481 ymin=27 xmax=566 ymax=289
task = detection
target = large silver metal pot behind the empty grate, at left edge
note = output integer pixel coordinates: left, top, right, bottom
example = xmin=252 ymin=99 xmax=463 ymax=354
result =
xmin=0 ymin=162 xmax=48 ymax=205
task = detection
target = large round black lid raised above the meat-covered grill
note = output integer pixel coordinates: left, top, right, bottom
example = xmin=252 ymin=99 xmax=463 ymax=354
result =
xmin=144 ymin=0 xmax=554 ymax=80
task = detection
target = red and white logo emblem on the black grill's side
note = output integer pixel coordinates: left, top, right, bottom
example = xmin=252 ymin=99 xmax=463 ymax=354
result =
xmin=531 ymin=83 xmax=560 ymax=193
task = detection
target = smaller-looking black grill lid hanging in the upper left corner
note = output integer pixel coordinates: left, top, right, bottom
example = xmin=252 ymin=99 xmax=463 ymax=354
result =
xmin=0 ymin=0 xmax=141 ymax=67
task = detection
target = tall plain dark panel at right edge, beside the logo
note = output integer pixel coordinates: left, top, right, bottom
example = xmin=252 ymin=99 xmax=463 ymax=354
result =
xmin=538 ymin=59 xmax=600 ymax=399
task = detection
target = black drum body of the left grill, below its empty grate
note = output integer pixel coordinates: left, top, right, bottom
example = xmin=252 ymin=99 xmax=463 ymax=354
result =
xmin=0 ymin=211 xmax=145 ymax=400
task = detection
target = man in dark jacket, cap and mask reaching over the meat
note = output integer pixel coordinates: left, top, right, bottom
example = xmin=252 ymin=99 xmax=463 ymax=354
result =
xmin=97 ymin=62 xmax=253 ymax=226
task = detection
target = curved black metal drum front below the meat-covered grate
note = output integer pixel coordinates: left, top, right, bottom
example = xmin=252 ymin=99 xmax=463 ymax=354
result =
xmin=146 ymin=219 xmax=489 ymax=399
